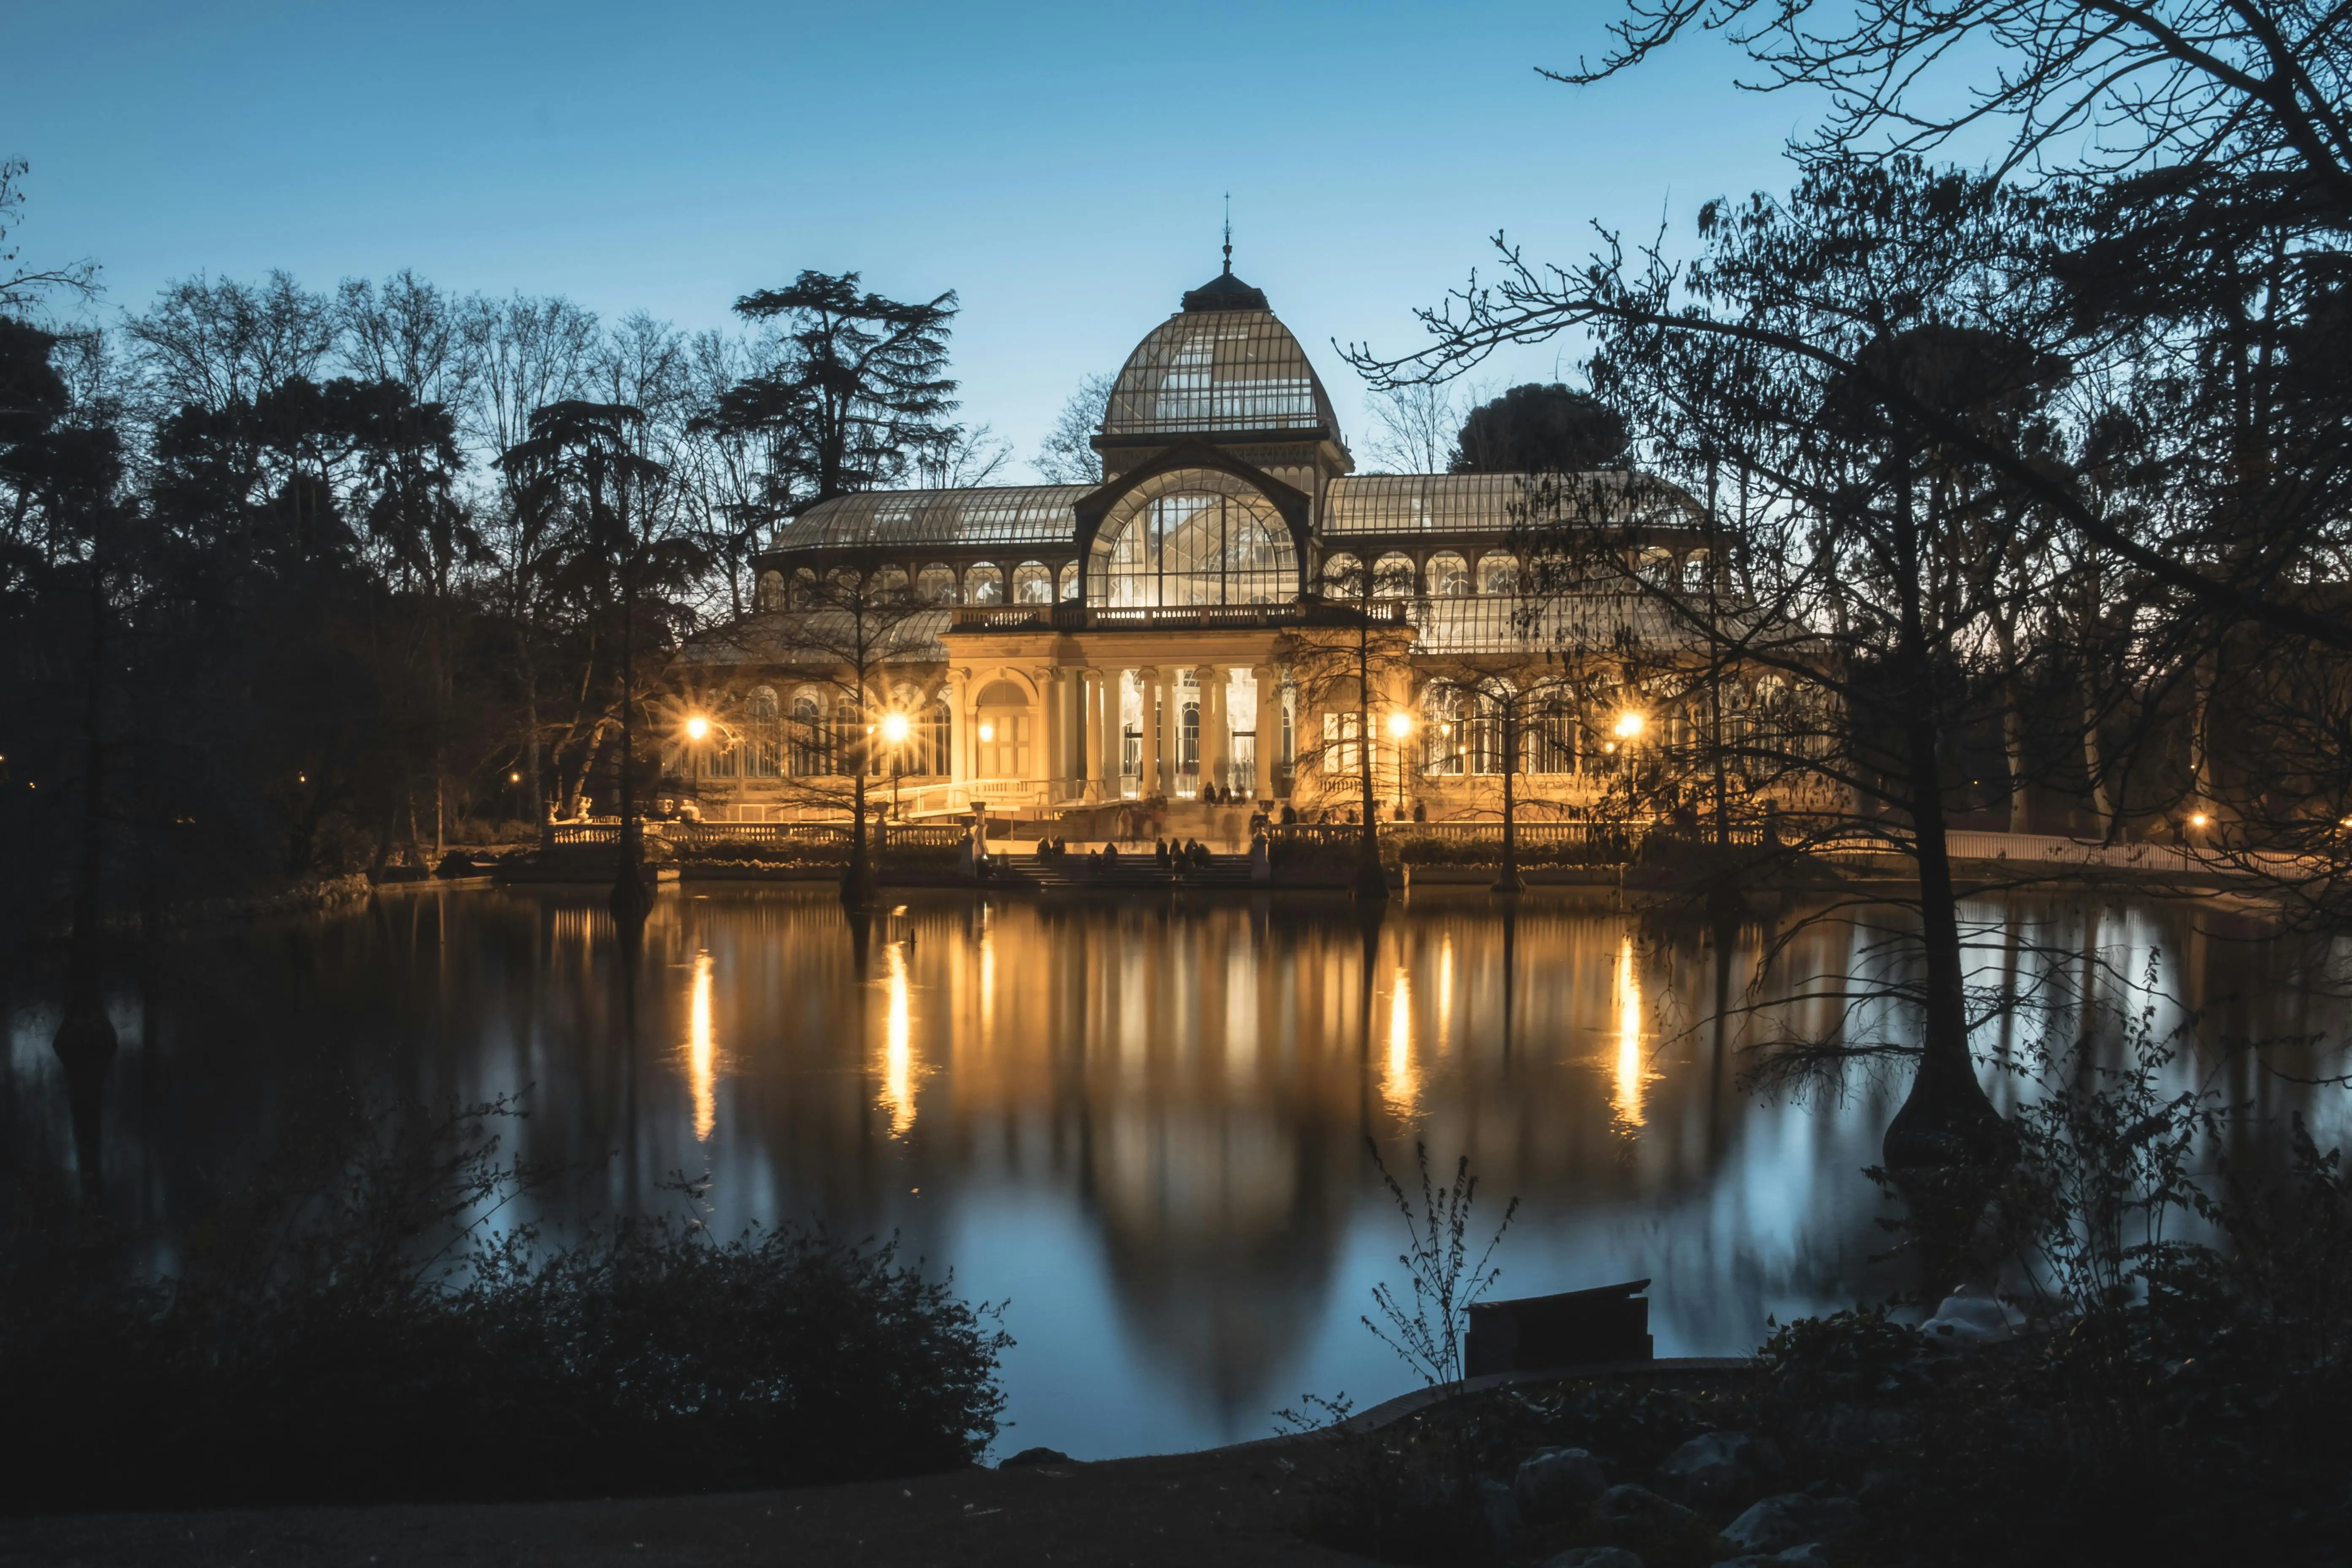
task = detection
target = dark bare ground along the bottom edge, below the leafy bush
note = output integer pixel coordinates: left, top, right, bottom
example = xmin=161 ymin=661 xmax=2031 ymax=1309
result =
xmin=0 ymin=1444 xmax=1369 ymax=1568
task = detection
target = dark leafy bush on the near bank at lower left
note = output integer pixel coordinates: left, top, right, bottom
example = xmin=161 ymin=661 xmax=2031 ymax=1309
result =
xmin=0 ymin=1100 xmax=1009 ymax=1511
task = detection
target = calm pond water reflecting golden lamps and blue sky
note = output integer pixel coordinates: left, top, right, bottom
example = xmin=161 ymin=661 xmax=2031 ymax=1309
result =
xmin=0 ymin=886 xmax=2345 ymax=1457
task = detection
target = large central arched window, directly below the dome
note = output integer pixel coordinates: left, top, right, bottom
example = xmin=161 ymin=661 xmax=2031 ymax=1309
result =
xmin=1087 ymin=468 xmax=1298 ymax=609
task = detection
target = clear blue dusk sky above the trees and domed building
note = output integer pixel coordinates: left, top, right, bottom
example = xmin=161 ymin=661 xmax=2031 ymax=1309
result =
xmin=0 ymin=0 xmax=1814 ymax=477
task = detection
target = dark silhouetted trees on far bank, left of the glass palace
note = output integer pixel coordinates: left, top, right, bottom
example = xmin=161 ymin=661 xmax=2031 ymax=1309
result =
xmin=0 ymin=228 xmax=1004 ymax=919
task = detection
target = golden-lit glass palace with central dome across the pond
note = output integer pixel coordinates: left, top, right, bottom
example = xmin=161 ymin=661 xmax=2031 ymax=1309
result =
xmin=680 ymin=268 xmax=1710 ymax=820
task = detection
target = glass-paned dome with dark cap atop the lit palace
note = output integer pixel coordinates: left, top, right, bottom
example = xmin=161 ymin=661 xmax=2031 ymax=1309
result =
xmin=1103 ymin=270 xmax=1338 ymax=442
